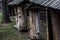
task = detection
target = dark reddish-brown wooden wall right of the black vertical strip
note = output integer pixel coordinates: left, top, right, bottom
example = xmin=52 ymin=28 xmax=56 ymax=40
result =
xmin=51 ymin=10 xmax=60 ymax=40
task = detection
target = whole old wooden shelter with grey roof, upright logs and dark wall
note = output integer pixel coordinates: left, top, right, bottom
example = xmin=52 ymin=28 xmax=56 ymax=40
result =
xmin=10 ymin=0 xmax=60 ymax=40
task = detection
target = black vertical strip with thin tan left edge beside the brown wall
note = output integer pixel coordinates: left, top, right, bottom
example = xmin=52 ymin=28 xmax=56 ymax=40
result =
xmin=46 ymin=8 xmax=53 ymax=40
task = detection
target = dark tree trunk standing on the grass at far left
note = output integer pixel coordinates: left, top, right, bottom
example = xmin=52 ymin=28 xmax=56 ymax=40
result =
xmin=2 ymin=0 xmax=11 ymax=23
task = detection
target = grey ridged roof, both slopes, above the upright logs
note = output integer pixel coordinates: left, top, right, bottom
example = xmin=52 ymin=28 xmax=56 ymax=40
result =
xmin=9 ymin=0 xmax=60 ymax=9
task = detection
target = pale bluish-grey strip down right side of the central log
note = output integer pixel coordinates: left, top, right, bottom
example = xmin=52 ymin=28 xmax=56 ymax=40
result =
xmin=34 ymin=11 xmax=40 ymax=39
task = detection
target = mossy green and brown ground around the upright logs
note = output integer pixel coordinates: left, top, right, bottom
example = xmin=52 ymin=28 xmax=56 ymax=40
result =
xmin=0 ymin=12 xmax=47 ymax=40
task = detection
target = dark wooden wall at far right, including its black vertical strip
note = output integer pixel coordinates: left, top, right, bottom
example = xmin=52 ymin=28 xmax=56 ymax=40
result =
xmin=47 ymin=8 xmax=60 ymax=40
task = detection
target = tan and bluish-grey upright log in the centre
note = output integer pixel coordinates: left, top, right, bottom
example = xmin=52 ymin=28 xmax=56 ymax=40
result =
xmin=29 ymin=11 xmax=40 ymax=40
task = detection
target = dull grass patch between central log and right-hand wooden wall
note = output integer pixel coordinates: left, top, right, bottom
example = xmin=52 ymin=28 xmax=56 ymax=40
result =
xmin=40 ymin=24 xmax=47 ymax=40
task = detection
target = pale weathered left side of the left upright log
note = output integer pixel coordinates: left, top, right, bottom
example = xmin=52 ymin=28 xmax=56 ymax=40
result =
xmin=16 ymin=6 xmax=22 ymax=30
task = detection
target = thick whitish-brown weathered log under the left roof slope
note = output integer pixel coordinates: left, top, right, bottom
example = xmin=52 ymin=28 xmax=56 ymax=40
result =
xmin=15 ymin=6 xmax=28 ymax=30
